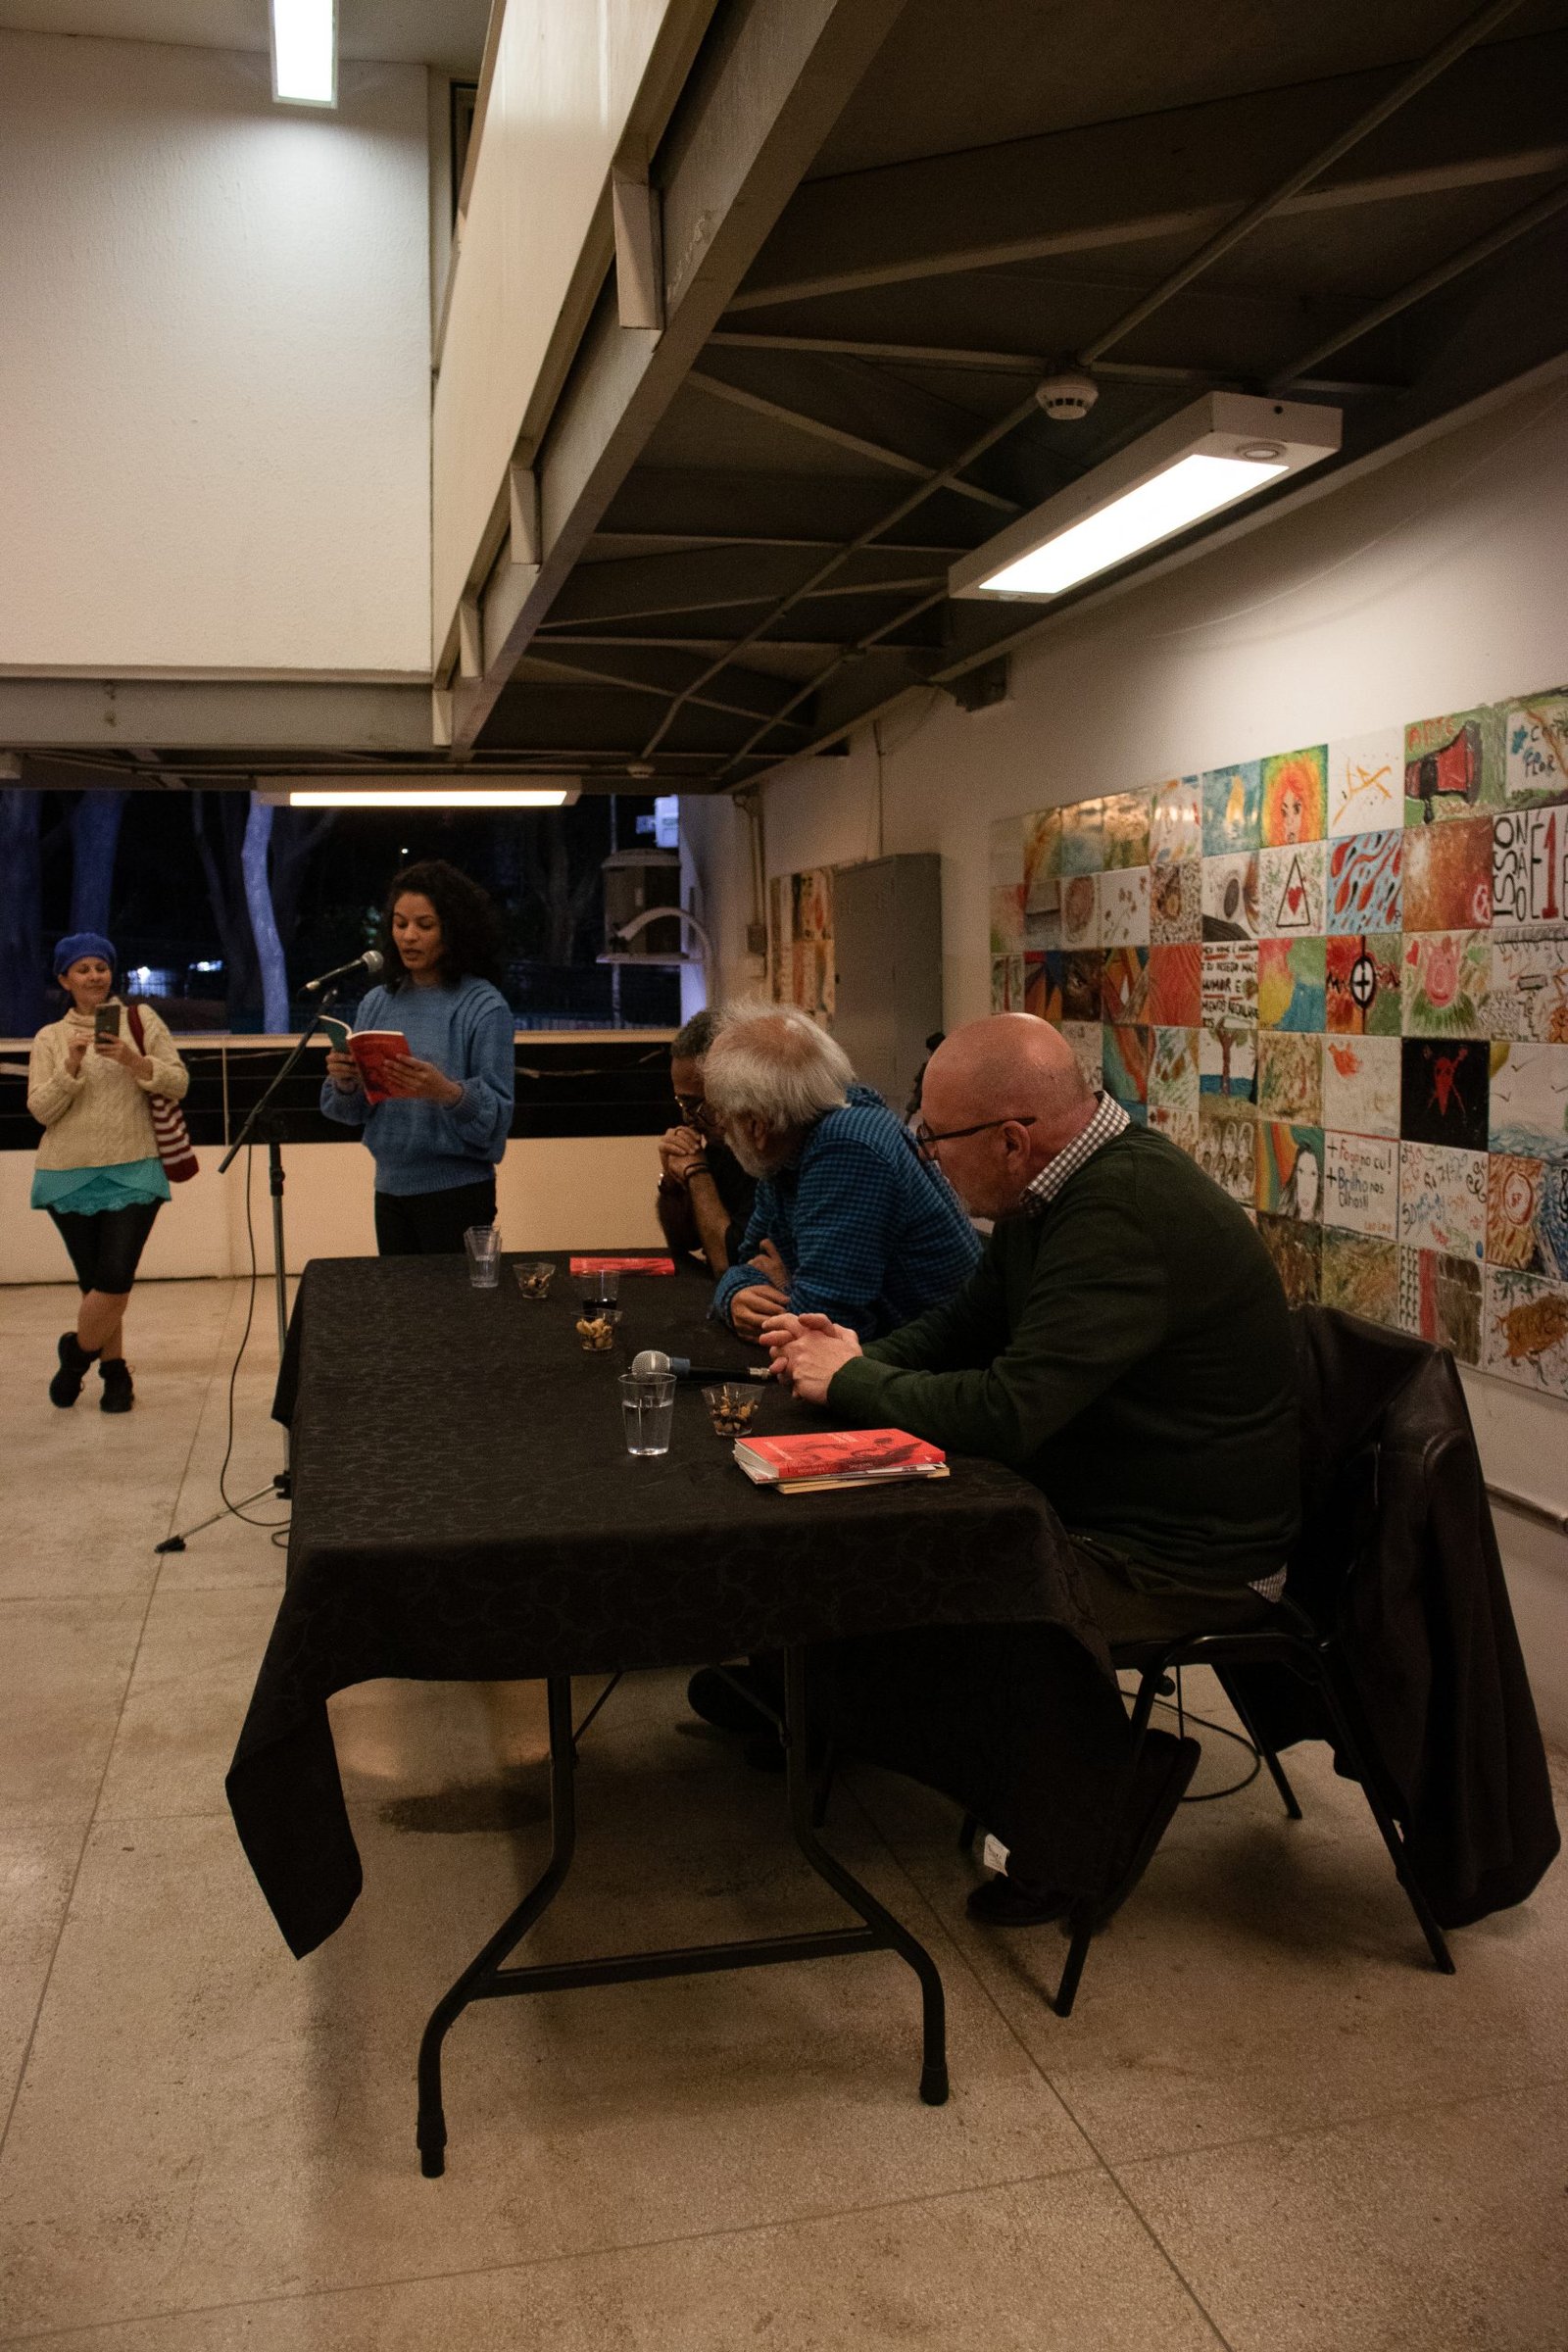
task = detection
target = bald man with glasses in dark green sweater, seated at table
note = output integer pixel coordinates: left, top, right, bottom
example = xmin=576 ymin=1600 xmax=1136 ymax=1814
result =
xmin=764 ymin=1013 xmax=1300 ymax=1924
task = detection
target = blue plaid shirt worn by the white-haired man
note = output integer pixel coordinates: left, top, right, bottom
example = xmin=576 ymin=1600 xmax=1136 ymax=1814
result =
xmin=712 ymin=1087 xmax=980 ymax=1339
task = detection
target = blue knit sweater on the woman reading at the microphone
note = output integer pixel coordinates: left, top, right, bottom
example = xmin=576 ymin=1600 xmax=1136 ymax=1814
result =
xmin=322 ymin=981 xmax=517 ymax=1198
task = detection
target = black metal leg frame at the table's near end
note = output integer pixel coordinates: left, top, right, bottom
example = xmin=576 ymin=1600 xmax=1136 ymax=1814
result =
xmin=418 ymin=1648 xmax=948 ymax=2180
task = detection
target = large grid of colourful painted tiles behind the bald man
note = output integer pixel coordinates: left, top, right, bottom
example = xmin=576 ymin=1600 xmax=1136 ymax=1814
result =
xmin=990 ymin=687 xmax=1568 ymax=1397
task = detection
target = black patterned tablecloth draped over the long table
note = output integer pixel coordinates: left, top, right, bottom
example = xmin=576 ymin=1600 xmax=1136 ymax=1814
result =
xmin=228 ymin=1253 xmax=1104 ymax=1954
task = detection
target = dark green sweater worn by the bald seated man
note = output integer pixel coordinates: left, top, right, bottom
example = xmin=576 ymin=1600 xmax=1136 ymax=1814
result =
xmin=827 ymin=1127 xmax=1300 ymax=1586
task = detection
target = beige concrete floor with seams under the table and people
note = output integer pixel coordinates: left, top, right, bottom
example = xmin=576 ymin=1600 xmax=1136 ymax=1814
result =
xmin=0 ymin=1282 xmax=1568 ymax=2352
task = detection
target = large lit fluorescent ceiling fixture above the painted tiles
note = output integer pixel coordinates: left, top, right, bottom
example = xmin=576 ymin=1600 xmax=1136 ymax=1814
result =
xmin=948 ymin=393 xmax=1340 ymax=602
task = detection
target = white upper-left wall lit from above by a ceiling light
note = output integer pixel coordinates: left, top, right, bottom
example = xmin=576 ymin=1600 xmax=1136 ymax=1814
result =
xmin=0 ymin=33 xmax=430 ymax=677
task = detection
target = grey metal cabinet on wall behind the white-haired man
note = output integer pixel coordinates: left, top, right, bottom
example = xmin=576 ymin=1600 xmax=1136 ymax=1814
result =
xmin=832 ymin=854 xmax=943 ymax=1112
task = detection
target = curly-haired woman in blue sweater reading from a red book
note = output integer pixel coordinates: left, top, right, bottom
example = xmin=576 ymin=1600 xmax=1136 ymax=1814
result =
xmin=322 ymin=858 xmax=514 ymax=1258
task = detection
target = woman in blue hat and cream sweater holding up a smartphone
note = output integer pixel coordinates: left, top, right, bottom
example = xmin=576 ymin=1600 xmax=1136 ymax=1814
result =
xmin=28 ymin=931 xmax=190 ymax=1413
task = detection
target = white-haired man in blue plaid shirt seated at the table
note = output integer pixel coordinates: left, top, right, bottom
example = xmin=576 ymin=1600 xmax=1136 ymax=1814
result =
xmin=703 ymin=1004 xmax=980 ymax=1339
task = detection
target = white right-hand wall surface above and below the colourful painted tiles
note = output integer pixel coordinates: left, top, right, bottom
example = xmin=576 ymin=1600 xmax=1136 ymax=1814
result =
xmin=682 ymin=362 xmax=1568 ymax=1742
